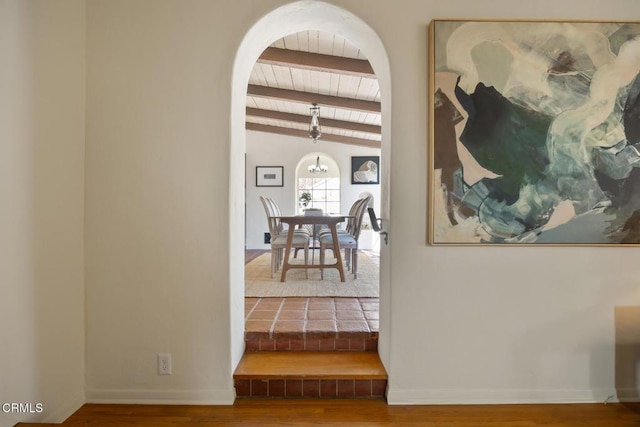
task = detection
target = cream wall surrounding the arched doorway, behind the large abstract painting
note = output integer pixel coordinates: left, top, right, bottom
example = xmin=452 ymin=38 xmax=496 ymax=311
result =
xmin=86 ymin=0 xmax=640 ymax=412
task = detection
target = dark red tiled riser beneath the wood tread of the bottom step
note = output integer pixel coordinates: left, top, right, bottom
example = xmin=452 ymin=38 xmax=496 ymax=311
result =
xmin=235 ymin=379 xmax=387 ymax=399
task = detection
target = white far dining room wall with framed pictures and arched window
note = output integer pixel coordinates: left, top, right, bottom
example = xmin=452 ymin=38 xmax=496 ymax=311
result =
xmin=245 ymin=132 xmax=380 ymax=249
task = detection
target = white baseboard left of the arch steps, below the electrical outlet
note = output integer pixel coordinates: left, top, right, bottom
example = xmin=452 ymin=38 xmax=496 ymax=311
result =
xmin=86 ymin=389 xmax=236 ymax=405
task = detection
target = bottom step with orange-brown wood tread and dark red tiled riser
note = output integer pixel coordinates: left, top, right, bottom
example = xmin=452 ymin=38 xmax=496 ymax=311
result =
xmin=234 ymin=352 xmax=387 ymax=398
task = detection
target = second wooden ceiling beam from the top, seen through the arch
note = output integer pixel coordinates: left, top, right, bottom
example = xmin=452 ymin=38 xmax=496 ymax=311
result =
xmin=247 ymin=85 xmax=382 ymax=113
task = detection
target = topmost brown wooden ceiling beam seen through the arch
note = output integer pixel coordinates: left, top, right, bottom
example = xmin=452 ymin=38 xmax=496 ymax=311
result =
xmin=258 ymin=47 xmax=376 ymax=79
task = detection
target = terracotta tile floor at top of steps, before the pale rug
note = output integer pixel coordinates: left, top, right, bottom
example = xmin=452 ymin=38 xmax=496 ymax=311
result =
xmin=245 ymin=297 xmax=379 ymax=336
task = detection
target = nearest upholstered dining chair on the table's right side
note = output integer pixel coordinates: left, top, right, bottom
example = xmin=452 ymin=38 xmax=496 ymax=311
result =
xmin=319 ymin=196 xmax=371 ymax=279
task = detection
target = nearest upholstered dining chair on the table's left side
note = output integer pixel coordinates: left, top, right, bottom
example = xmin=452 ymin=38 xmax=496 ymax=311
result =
xmin=260 ymin=196 xmax=310 ymax=278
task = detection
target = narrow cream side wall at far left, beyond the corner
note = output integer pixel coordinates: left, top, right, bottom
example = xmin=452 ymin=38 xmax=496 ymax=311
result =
xmin=0 ymin=0 xmax=85 ymax=426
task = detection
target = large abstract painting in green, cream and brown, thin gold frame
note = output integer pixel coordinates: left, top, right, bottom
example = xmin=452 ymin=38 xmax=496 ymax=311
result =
xmin=429 ymin=20 xmax=640 ymax=245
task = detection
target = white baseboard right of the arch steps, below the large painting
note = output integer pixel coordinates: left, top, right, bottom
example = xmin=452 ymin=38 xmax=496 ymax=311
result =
xmin=387 ymin=387 xmax=618 ymax=405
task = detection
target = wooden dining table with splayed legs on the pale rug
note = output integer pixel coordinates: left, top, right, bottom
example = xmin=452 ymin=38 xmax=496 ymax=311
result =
xmin=278 ymin=215 xmax=351 ymax=282
